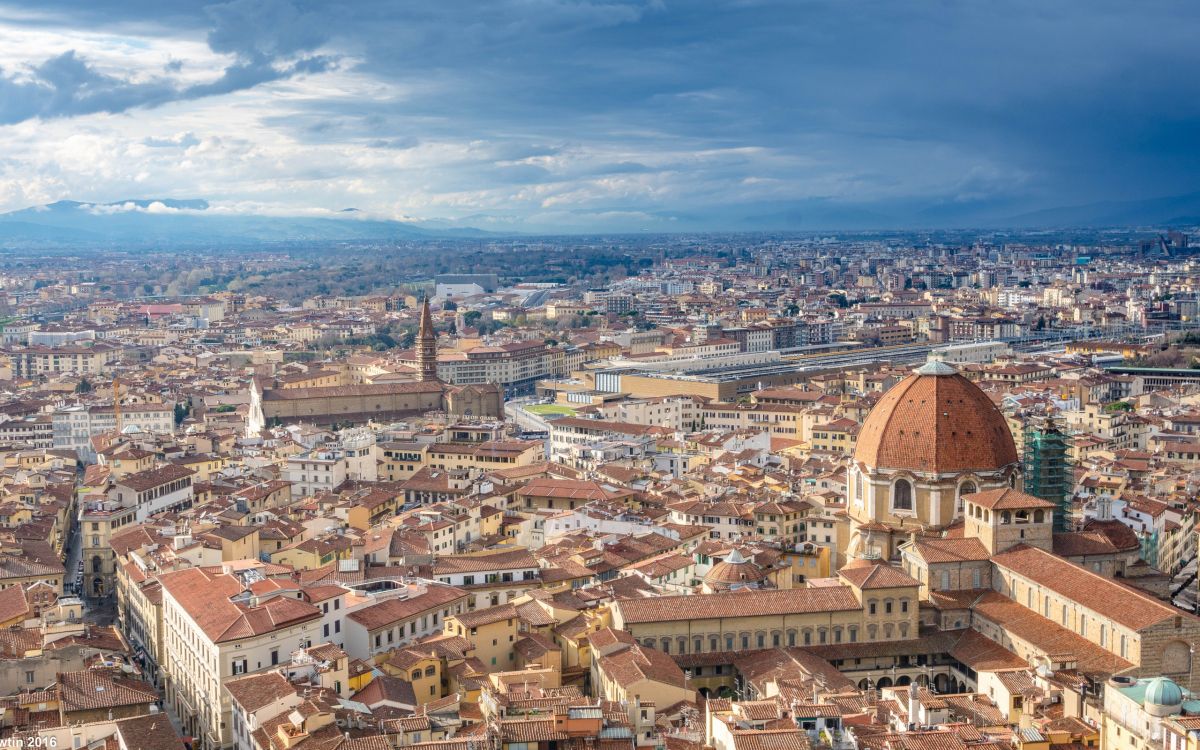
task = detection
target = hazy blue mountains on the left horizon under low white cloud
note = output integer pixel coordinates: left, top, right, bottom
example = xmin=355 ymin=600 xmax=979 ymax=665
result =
xmin=0 ymin=198 xmax=484 ymax=246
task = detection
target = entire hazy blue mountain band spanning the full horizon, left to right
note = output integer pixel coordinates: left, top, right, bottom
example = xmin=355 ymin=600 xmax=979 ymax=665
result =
xmin=0 ymin=192 xmax=1200 ymax=242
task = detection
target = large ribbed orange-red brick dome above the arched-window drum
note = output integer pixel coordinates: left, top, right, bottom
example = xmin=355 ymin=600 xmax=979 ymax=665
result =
xmin=854 ymin=361 xmax=1016 ymax=474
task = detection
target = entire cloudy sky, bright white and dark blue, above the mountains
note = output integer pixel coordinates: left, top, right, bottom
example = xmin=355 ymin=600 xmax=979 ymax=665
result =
xmin=0 ymin=0 xmax=1200 ymax=230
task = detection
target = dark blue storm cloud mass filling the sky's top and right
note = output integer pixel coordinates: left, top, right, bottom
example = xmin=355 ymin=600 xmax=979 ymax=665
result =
xmin=0 ymin=0 xmax=1200 ymax=223
